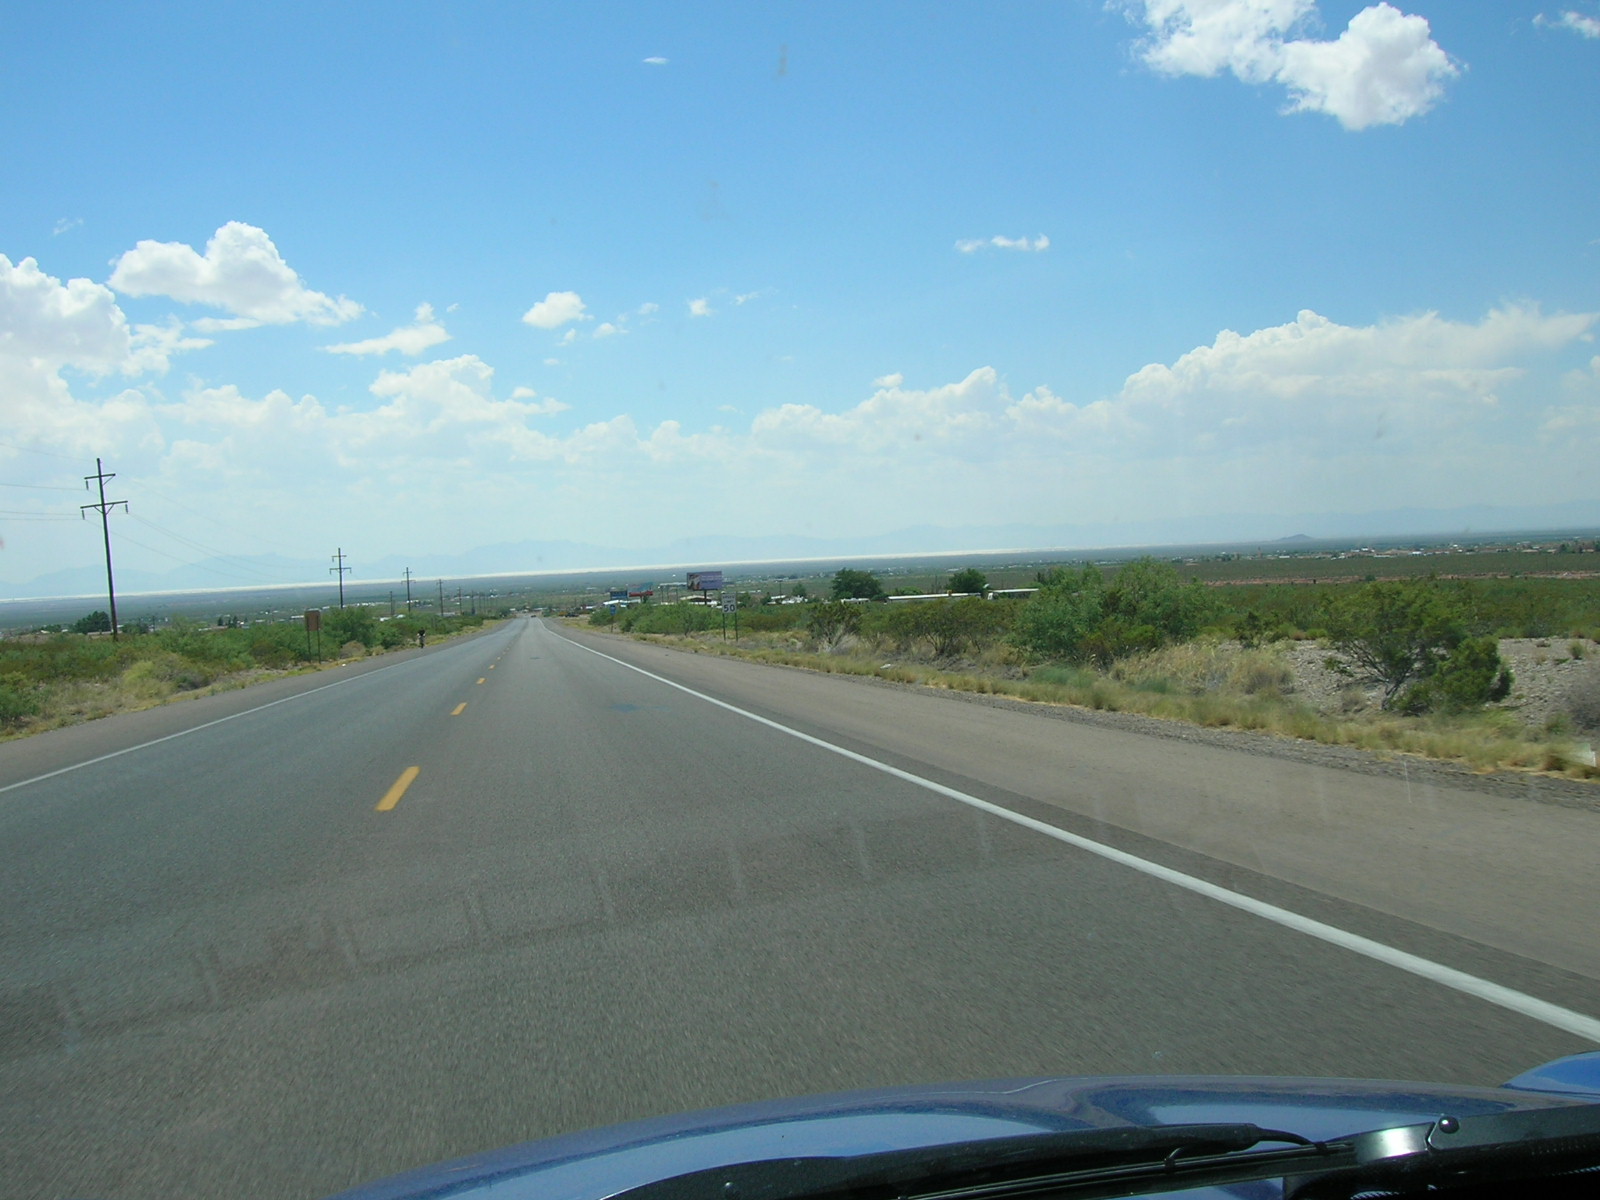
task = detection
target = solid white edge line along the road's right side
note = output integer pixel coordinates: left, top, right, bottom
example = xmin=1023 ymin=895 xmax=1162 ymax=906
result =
xmin=562 ymin=637 xmax=1600 ymax=1043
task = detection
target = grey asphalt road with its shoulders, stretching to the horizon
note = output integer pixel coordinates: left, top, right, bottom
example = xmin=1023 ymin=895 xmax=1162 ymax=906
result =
xmin=0 ymin=619 xmax=1600 ymax=1200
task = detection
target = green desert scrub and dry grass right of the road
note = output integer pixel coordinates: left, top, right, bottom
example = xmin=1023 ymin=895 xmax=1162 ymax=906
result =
xmin=590 ymin=558 xmax=1600 ymax=778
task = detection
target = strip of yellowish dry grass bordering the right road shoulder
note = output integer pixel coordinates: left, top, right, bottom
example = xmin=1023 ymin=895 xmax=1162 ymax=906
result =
xmin=601 ymin=634 xmax=1600 ymax=779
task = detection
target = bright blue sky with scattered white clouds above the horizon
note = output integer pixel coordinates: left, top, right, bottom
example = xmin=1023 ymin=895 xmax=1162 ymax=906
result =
xmin=0 ymin=0 xmax=1600 ymax=594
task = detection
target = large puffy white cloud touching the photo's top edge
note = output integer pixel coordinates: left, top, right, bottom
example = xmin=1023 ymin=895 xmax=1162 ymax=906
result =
xmin=1125 ymin=0 xmax=1461 ymax=130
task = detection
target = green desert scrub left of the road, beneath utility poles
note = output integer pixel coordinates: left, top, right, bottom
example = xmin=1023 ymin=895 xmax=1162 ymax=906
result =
xmin=0 ymin=606 xmax=486 ymax=736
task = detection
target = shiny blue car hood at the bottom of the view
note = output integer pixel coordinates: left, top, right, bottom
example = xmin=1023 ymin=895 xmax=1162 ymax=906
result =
xmin=336 ymin=1053 xmax=1600 ymax=1200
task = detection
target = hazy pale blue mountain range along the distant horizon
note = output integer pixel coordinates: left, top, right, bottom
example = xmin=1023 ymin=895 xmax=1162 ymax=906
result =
xmin=0 ymin=501 xmax=1600 ymax=598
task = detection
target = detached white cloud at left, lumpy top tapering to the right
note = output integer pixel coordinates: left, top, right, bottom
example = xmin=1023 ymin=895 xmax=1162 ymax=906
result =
xmin=110 ymin=221 xmax=363 ymax=328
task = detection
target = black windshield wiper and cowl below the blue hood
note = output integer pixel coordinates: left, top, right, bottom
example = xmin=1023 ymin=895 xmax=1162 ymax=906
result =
xmin=618 ymin=1104 xmax=1600 ymax=1200
